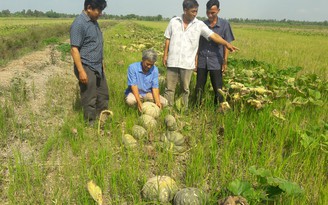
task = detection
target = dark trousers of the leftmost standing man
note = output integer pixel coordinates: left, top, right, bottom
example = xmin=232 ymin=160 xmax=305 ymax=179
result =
xmin=75 ymin=65 xmax=109 ymax=121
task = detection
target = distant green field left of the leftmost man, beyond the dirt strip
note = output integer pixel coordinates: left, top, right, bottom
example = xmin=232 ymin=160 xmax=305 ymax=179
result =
xmin=0 ymin=18 xmax=114 ymax=66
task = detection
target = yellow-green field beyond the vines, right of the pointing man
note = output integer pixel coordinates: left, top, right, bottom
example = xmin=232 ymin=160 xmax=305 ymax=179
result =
xmin=141 ymin=22 xmax=328 ymax=78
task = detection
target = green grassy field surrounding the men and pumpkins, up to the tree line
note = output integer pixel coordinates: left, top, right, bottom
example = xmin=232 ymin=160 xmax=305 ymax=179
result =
xmin=0 ymin=18 xmax=328 ymax=205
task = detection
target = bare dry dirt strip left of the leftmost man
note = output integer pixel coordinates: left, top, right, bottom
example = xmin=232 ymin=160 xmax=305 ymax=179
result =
xmin=0 ymin=43 xmax=76 ymax=204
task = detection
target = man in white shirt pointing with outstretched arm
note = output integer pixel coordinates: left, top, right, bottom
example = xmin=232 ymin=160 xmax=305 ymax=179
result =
xmin=163 ymin=0 xmax=238 ymax=108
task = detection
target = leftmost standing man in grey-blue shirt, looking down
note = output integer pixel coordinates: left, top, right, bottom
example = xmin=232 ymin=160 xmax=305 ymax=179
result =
xmin=70 ymin=0 xmax=109 ymax=125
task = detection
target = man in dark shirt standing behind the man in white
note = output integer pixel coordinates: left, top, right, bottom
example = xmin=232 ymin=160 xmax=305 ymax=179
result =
xmin=195 ymin=0 xmax=235 ymax=108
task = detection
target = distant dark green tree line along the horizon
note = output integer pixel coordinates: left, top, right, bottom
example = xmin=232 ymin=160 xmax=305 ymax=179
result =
xmin=0 ymin=9 xmax=328 ymax=26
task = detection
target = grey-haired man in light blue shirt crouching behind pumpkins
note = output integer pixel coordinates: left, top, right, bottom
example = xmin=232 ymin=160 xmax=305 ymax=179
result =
xmin=125 ymin=49 xmax=167 ymax=112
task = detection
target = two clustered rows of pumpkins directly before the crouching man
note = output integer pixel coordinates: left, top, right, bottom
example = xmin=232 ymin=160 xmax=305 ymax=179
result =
xmin=122 ymin=102 xmax=186 ymax=153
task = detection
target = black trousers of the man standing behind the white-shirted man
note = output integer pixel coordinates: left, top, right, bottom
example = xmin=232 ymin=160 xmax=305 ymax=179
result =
xmin=195 ymin=68 xmax=223 ymax=105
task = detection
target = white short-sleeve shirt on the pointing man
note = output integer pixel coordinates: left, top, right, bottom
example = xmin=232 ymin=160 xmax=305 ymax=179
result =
xmin=164 ymin=17 xmax=213 ymax=70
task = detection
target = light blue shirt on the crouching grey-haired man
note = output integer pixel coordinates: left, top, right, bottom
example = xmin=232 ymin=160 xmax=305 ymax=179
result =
xmin=125 ymin=62 xmax=159 ymax=96
